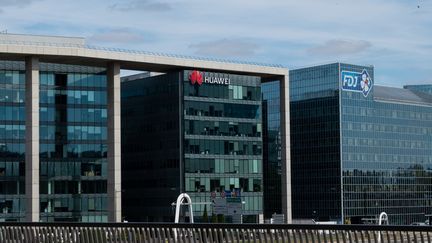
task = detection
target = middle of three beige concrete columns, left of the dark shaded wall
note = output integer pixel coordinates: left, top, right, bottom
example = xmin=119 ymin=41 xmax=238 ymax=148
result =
xmin=107 ymin=62 xmax=121 ymax=222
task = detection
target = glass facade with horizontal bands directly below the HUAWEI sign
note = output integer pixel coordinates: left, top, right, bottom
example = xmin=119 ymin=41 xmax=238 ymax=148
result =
xmin=182 ymin=71 xmax=263 ymax=222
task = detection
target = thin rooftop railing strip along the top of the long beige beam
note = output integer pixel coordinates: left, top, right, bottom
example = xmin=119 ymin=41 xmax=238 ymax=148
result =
xmin=0 ymin=40 xmax=285 ymax=68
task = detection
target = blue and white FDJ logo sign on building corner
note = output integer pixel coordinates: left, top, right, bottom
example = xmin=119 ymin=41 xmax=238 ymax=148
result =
xmin=341 ymin=69 xmax=373 ymax=97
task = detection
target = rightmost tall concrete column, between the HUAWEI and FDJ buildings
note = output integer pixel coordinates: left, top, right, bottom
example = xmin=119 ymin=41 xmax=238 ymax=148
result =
xmin=280 ymin=73 xmax=292 ymax=224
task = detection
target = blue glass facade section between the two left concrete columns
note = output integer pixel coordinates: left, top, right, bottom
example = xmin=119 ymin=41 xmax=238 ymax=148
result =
xmin=39 ymin=64 xmax=108 ymax=222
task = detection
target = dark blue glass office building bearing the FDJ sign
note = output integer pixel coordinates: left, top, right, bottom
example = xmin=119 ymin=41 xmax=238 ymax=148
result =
xmin=290 ymin=63 xmax=432 ymax=224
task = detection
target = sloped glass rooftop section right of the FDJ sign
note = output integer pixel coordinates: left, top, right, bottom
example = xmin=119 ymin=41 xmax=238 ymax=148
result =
xmin=374 ymin=85 xmax=432 ymax=106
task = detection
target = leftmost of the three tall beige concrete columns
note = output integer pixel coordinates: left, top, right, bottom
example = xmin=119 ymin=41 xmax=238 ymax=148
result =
xmin=25 ymin=57 xmax=40 ymax=222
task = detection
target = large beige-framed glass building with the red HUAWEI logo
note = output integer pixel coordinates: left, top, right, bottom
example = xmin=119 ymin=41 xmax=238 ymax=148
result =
xmin=0 ymin=33 xmax=291 ymax=222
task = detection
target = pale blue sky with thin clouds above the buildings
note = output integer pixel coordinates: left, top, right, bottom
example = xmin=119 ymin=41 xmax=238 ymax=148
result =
xmin=0 ymin=0 xmax=432 ymax=86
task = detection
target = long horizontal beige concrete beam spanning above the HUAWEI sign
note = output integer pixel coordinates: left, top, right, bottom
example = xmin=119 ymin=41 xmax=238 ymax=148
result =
xmin=0 ymin=43 xmax=288 ymax=77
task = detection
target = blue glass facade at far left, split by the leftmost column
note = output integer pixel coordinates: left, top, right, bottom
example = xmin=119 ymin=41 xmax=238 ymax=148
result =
xmin=0 ymin=61 xmax=108 ymax=222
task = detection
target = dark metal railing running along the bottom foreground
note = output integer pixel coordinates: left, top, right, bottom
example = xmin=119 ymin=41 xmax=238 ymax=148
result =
xmin=0 ymin=223 xmax=432 ymax=243
